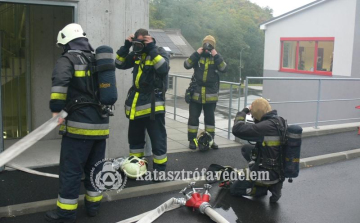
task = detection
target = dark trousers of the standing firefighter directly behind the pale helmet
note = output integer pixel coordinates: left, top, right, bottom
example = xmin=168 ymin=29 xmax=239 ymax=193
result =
xmin=128 ymin=114 xmax=167 ymax=171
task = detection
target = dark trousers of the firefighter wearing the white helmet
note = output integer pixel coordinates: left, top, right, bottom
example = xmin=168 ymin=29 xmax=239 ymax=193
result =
xmin=57 ymin=136 xmax=106 ymax=218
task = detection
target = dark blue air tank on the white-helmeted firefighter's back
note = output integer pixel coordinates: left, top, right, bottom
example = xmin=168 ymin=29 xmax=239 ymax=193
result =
xmin=95 ymin=46 xmax=118 ymax=106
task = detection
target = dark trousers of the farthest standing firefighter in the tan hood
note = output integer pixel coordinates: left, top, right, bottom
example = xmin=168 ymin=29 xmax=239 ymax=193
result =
xmin=188 ymin=101 xmax=216 ymax=141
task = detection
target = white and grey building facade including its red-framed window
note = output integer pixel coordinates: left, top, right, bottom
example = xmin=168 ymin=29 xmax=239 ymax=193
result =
xmin=260 ymin=0 xmax=360 ymax=126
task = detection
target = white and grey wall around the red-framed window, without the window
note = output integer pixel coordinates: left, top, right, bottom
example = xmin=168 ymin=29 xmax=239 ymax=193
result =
xmin=263 ymin=0 xmax=360 ymax=126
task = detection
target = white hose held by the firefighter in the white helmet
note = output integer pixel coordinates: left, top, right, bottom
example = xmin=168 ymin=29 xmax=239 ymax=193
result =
xmin=0 ymin=111 xmax=67 ymax=166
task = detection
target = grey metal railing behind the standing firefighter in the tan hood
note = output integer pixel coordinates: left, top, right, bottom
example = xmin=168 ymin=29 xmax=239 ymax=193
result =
xmin=166 ymin=74 xmax=241 ymax=139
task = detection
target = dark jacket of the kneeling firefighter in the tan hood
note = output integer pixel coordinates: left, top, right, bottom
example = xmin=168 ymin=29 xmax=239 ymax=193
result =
xmin=232 ymin=108 xmax=283 ymax=184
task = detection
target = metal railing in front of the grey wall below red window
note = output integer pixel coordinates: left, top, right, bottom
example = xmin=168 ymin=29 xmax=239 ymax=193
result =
xmin=244 ymin=77 xmax=360 ymax=129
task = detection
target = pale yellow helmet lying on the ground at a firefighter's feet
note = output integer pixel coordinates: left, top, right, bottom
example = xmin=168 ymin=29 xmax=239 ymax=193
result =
xmin=121 ymin=156 xmax=148 ymax=179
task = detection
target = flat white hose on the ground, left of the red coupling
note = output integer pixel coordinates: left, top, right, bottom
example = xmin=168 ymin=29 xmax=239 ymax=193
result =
xmin=117 ymin=198 xmax=182 ymax=223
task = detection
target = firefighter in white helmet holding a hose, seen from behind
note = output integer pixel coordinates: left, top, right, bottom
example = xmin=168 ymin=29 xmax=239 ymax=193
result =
xmin=45 ymin=23 xmax=109 ymax=222
